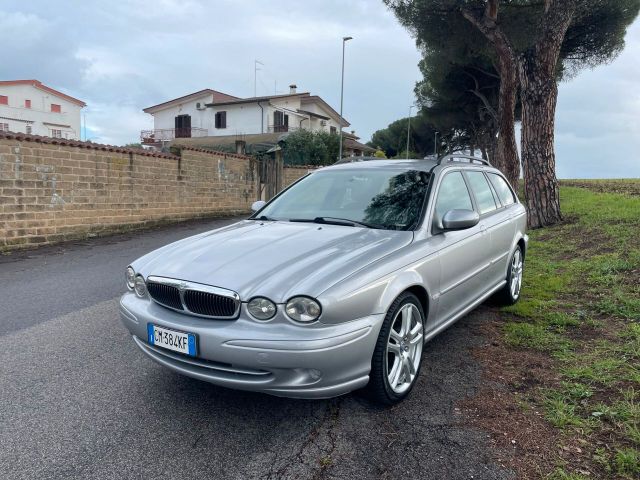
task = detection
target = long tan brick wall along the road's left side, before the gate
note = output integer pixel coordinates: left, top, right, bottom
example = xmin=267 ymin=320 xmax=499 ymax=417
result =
xmin=0 ymin=132 xmax=257 ymax=250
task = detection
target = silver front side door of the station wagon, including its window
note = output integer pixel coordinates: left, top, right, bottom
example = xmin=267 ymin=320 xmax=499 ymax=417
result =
xmin=431 ymin=170 xmax=489 ymax=323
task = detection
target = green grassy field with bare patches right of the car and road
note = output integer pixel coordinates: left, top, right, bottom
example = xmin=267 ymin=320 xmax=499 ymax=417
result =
xmin=500 ymin=180 xmax=640 ymax=479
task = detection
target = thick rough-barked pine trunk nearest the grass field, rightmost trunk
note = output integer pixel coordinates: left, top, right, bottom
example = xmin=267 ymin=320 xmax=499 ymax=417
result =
xmin=519 ymin=53 xmax=562 ymax=228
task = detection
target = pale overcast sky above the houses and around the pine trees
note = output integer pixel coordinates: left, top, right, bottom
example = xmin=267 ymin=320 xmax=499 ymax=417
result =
xmin=0 ymin=0 xmax=640 ymax=178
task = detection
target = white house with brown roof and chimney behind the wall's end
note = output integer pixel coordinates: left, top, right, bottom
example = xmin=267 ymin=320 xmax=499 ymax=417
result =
xmin=140 ymin=85 xmax=350 ymax=146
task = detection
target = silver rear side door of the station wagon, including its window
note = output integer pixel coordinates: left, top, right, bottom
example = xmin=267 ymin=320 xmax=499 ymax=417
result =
xmin=465 ymin=170 xmax=515 ymax=290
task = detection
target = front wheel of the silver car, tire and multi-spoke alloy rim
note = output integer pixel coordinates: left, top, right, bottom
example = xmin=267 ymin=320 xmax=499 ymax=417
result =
xmin=366 ymin=292 xmax=425 ymax=405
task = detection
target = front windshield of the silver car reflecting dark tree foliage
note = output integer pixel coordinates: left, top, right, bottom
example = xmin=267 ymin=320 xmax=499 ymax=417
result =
xmin=257 ymin=168 xmax=429 ymax=230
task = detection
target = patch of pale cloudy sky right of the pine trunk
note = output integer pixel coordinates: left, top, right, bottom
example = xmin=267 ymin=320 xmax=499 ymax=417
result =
xmin=556 ymin=21 xmax=640 ymax=178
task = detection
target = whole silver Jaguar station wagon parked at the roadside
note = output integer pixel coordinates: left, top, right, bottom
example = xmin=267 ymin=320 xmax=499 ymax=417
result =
xmin=120 ymin=156 xmax=528 ymax=404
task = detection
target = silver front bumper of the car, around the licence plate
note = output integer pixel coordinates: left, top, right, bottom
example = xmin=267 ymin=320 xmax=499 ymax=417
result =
xmin=120 ymin=292 xmax=384 ymax=398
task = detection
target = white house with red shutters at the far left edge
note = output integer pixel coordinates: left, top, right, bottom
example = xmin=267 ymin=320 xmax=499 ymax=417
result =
xmin=0 ymin=80 xmax=86 ymax=140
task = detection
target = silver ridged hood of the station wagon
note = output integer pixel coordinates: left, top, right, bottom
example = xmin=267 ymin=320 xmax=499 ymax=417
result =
xmin=133 ymin=220 xmax=413 ymax=303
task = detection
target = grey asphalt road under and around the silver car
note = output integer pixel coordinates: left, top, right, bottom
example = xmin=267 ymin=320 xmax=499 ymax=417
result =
xmin=0 ymin=220 xmax=513 ymax=480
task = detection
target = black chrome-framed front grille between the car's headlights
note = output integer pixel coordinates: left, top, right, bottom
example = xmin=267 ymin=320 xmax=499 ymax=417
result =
xmin=147 ymin=276 xmax=240 ymax=320
